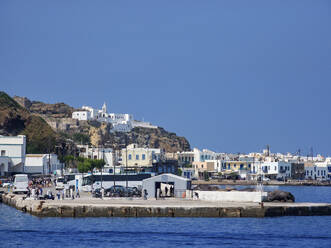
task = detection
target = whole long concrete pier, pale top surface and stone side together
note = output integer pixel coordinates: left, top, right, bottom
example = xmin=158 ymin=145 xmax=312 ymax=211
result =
xmin=2 ymin=194 xmax=331 ymax=217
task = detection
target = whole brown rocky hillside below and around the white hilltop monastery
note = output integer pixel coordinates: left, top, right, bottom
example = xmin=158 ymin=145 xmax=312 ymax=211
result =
xmin=0 ymin=92 xmax=190 ymax=154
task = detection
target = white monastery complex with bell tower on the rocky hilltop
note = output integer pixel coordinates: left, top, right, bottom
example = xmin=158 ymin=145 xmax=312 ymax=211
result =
xmin=72 ymin=103 xmax=157 ymax=132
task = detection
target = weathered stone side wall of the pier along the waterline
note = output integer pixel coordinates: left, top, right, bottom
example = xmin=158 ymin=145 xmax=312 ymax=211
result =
xmin=3 ymin=194 xmax=331 ymax=217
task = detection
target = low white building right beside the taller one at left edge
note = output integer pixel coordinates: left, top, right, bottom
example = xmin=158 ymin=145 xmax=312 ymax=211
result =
xmin=24 ymin=154 xmax=62 ymax=175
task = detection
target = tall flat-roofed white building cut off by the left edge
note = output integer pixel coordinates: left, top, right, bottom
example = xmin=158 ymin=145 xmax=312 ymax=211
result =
xmin=0 ymin=135 xmax=26 ymax=175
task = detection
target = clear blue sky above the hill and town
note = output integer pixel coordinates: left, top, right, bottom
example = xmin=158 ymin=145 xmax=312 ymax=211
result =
xmin=0 ymin=0 xmax=331 ymax=155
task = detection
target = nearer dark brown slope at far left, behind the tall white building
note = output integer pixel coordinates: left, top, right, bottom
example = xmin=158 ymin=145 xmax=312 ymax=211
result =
xmin=0 ymin=92 xmax=56 ymax=153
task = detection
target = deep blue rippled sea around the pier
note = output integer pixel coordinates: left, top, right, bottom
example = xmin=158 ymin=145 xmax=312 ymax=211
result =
xmin=0 ymin=186 xmax=331 ymax=248
